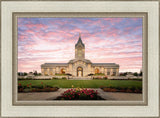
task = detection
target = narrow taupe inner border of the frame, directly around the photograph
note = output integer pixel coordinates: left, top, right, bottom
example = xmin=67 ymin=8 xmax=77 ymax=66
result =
xmin=12 ymin=12 xmax=147 ymax=106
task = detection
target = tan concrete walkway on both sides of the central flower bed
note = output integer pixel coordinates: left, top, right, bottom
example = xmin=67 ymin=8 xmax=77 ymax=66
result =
xmin=18 ymin=89 xmax=142 ymax=101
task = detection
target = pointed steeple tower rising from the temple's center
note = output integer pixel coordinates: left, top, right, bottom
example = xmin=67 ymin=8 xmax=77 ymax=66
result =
xmin=75 ymin=33 xmax=85 ymax=59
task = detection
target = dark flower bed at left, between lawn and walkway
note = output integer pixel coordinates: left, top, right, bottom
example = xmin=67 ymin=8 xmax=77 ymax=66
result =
xmin=18 ymin=83 xmax=59 ymax=92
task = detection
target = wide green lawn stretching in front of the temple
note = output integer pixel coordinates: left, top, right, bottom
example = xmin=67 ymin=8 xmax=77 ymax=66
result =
xmin=18 ymin=80 xmax=142 ymax=88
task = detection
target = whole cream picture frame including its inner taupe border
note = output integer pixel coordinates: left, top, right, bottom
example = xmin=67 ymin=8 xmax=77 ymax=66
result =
xmin=1 ymin=1 xmax=159 ymax=118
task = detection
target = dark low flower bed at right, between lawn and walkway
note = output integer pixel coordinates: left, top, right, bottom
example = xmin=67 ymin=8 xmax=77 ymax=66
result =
xmin=100 ymin=87 xmax=142 ymax=93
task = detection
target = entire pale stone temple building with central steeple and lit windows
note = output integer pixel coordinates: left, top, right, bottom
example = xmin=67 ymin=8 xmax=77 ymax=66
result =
xmin=41 ymin=35 xmax=119 ymax=77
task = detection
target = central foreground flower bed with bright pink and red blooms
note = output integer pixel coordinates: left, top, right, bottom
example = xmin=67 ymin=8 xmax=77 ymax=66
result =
xmin=56 ymin=88 xmax=104 ymax=100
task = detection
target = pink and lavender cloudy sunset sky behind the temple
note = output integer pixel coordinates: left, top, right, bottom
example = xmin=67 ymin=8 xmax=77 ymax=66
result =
xmin=18 ymin=18 xmax=142 ymax=72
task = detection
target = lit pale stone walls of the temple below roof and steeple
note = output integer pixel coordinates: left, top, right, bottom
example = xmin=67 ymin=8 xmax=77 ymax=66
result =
xmin=41 ymin=61 xmax=119 ymax=77
